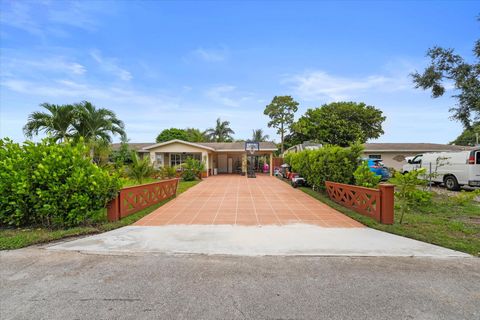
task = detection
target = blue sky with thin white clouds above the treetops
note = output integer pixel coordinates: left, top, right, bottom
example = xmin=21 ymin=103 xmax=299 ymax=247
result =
xmin=0 ymin=0 xmax=480 ymax=143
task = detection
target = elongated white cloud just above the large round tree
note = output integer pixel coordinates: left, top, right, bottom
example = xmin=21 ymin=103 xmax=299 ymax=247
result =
xmin=284 ymin=70 xmax=411 ymax=101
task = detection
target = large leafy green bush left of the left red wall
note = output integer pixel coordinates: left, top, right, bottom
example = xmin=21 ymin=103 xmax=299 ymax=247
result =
xmin=0 ymin=139 xmax=121 ymax=227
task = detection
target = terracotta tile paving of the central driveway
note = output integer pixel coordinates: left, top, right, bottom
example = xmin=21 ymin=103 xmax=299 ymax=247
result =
xmin=135 ymin=175 xmax=363 ymax=228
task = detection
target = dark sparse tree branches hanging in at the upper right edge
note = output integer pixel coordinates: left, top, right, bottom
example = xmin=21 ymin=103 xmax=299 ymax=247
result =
xmin=412 ymin=18 xmax=480 ymax=128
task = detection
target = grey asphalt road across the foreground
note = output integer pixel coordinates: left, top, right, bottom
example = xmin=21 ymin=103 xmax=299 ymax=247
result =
xmin=0 ymin=248 xmax=480 ymax=320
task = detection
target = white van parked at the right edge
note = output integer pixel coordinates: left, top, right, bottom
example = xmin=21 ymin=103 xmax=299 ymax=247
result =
xmin=402 ymin=149 xmax=480 ymax=190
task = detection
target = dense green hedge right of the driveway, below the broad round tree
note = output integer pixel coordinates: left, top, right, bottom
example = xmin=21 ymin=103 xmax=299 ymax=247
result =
xmin=285 ymin=144 xmax=363 ymax=189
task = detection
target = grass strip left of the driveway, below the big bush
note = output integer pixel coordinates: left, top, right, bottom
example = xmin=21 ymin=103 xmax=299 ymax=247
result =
xmin=0 ymin=180 xmax=200 ymax=250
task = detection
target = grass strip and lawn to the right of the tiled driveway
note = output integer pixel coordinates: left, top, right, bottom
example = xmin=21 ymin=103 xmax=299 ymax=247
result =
xmin=299 ymin=187 xmax=480 ymax=256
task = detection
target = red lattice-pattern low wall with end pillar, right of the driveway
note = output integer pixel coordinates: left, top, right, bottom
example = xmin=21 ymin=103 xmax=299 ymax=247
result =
xmin=325 ymin=181 xmax=395 ymax=224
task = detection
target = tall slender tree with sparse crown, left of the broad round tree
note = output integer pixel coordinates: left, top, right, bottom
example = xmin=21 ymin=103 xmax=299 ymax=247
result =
xmin=263 ymin=96 xmax=298 ymax=153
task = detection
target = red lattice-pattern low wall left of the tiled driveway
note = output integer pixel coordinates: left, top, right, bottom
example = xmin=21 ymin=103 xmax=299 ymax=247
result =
xmin=107 ymin=179 xmax=179 ymax=221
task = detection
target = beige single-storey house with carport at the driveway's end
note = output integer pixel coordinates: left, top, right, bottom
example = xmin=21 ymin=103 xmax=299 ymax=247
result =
xmin=112 ymin=139 xmax=277 ymax=176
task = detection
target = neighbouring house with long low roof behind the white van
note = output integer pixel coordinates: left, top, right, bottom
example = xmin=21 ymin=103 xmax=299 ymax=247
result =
xmin=363 ymin=143 xmax=470 ymax=170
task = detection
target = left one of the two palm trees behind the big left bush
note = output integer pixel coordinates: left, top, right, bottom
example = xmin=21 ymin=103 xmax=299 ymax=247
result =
xmin=23 ymin=103 xmax=75 ymax=141
